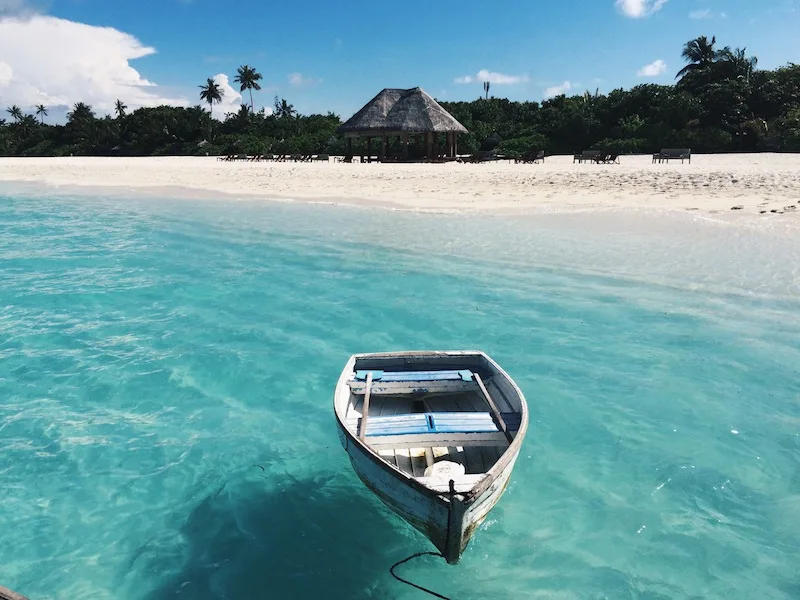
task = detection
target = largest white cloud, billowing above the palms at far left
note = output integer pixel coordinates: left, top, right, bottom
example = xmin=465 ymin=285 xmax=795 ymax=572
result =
xmin=0 ymin=14 xmax=188 ymax=113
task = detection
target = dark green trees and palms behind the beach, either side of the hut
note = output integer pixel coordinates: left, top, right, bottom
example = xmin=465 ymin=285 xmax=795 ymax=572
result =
xmin=0 ymin=36 xmax=800 ymax=156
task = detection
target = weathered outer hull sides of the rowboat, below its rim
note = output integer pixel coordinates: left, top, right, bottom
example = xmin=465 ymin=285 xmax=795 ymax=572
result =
xmin=339 ymin=427 xmax=519 ymax=564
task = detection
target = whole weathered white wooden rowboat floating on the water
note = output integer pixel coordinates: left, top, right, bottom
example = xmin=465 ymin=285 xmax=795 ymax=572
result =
xmin=333 ymin=352 xmax=528 ymax=564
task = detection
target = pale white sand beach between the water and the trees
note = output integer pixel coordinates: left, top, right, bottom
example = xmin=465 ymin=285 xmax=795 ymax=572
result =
xmin=0 ymin=154 xmax=800 ymax=217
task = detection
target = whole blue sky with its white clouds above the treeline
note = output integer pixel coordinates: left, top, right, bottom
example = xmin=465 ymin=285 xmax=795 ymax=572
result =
xmin=0 ymin=0 xmax=800 ymax=121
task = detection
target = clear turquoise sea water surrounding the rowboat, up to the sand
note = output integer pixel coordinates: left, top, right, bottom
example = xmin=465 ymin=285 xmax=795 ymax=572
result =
xmin=0 ymin=193 xmax=800 ymax=600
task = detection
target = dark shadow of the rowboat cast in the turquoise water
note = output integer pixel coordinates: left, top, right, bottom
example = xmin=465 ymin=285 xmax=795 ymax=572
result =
xmin=146 ymin=472 xmax=421 ymax=600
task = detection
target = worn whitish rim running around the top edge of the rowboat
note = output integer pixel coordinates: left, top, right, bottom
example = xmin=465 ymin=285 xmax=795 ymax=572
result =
xmin=333 ymin=350 xmax=528 ymax=505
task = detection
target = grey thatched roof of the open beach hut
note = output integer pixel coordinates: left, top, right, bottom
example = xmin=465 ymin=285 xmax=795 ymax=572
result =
xmin=337 ymin=88 xmax=467 ymax=137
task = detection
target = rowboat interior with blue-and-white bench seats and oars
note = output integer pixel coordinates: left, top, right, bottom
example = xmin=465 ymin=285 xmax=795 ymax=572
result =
xmin=340 ymin=355 xmax=523 ymax=492
